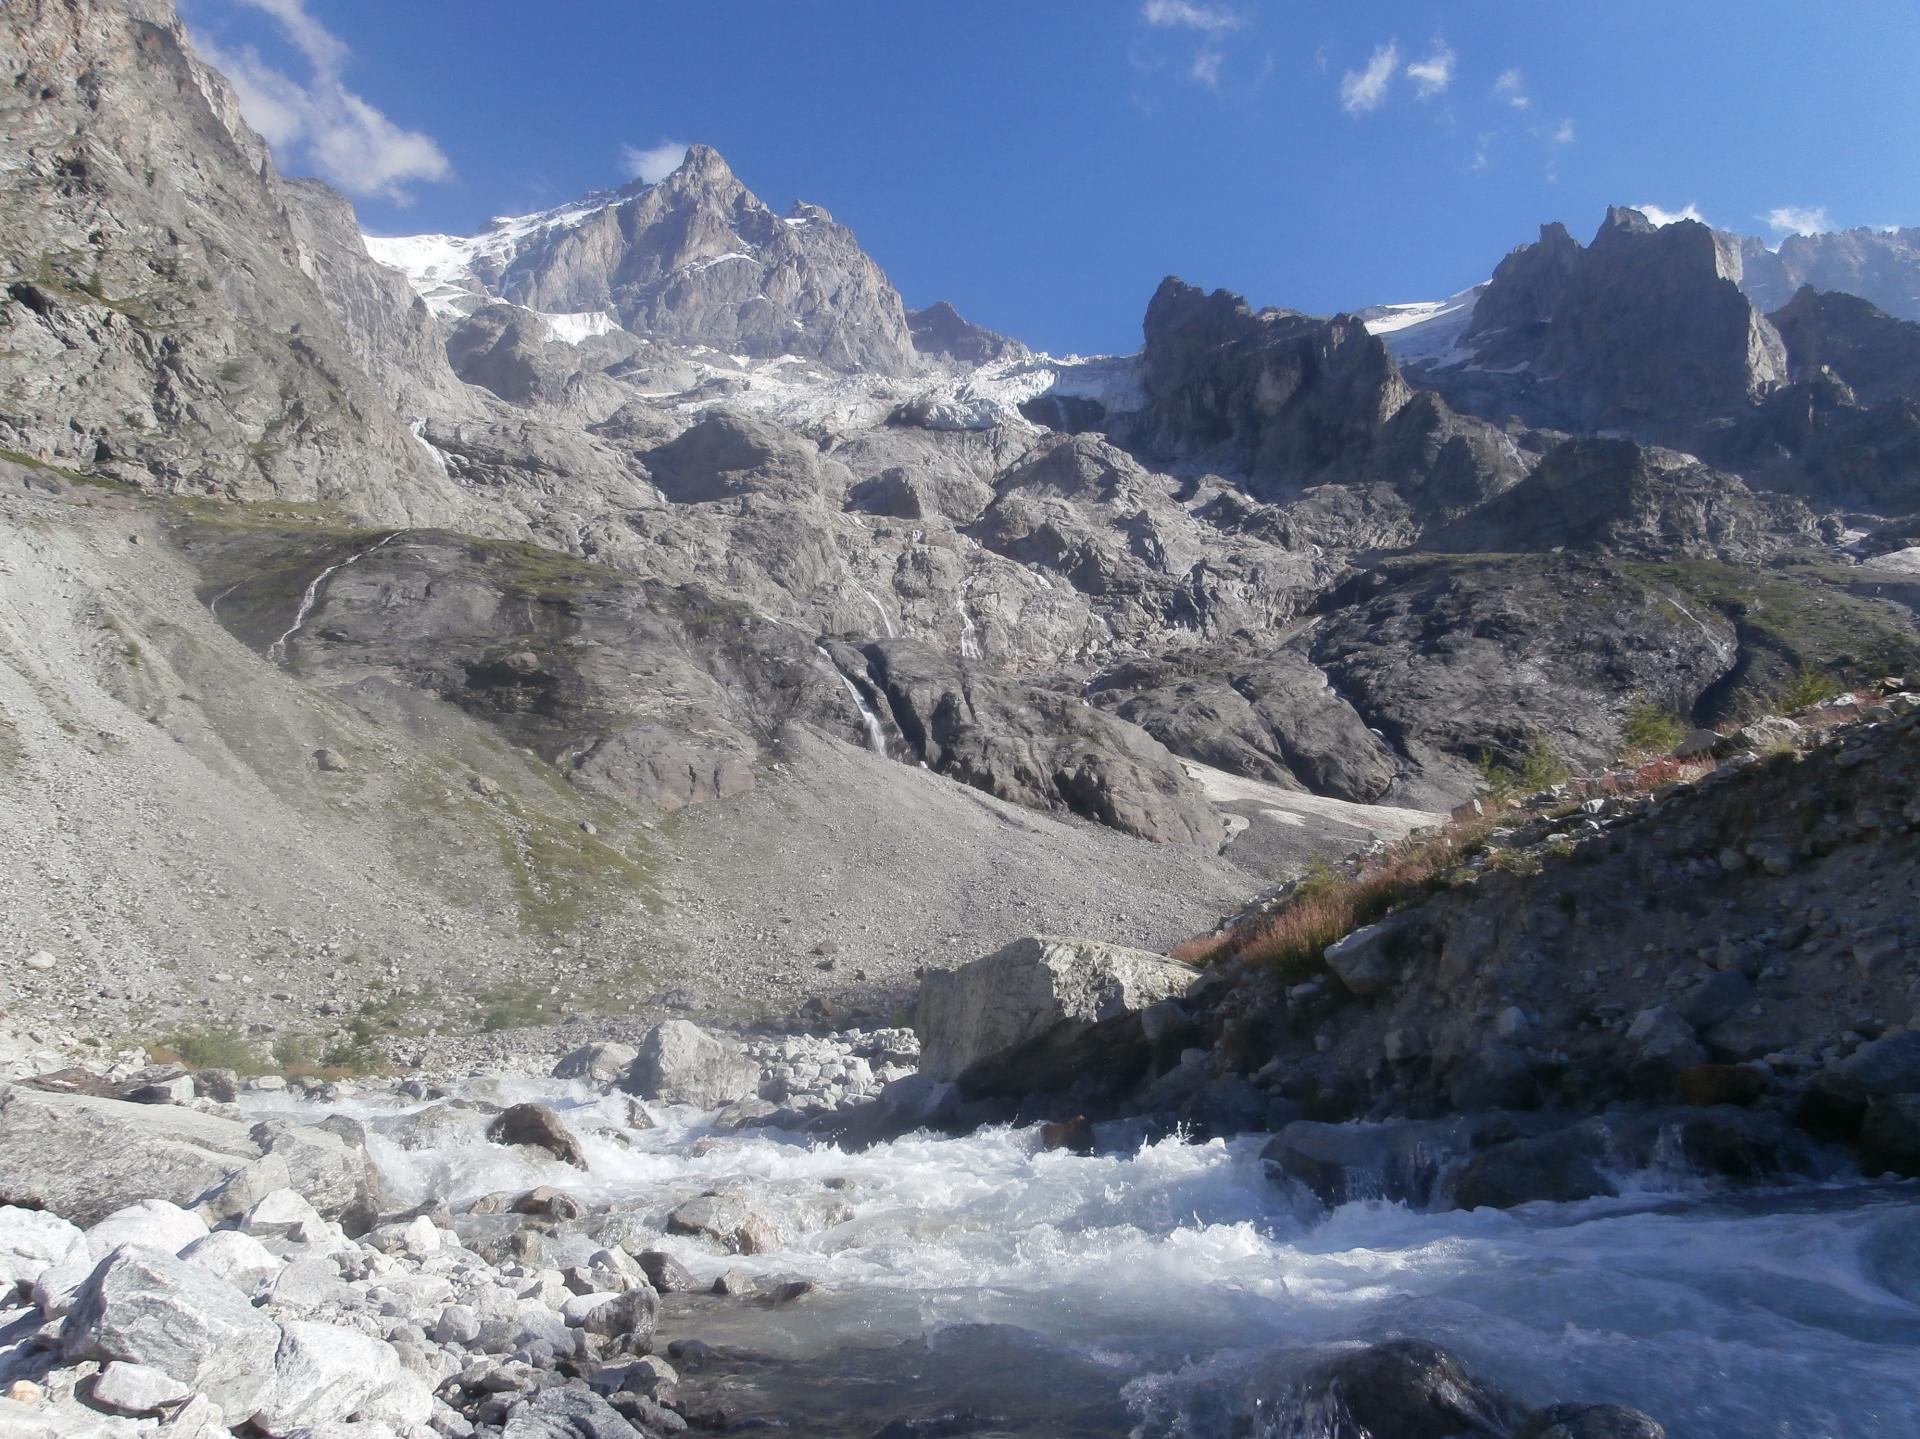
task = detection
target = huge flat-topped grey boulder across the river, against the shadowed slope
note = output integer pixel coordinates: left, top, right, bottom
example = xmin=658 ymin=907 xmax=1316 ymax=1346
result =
xmin=914 ymin=936 xmax=1198 ymax=1093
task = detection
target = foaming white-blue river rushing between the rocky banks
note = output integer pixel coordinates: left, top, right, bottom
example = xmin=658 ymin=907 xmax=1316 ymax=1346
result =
xmin=259 ymin=1082 xmax=1920 ymax=1439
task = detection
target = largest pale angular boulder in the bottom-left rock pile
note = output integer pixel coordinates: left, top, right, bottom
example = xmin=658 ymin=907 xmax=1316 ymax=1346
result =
xmin=61 ymin=1247 xmax=280 ymax=1414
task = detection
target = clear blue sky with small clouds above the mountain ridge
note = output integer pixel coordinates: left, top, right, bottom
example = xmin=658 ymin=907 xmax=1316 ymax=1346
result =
xmin=180 ymin=0 xmax=1920 ymax=352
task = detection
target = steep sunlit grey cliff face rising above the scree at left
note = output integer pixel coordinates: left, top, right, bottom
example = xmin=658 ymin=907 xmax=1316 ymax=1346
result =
xmin=0 ymin=0 xmax=459 ymax=521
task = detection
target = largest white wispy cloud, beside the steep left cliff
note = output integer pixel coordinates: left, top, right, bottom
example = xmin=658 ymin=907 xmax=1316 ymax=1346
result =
xmin=196 ymin=0 xmax=453 ymax=206
